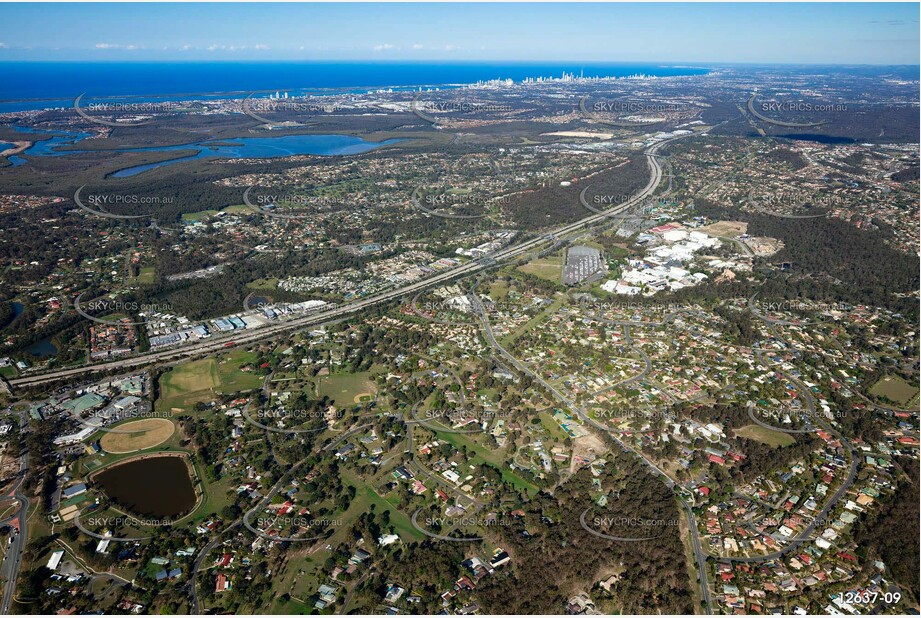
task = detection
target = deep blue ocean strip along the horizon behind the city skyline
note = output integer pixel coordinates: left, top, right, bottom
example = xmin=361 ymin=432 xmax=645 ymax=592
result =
xmin=0 ymin=61 xmax=709 ymax=112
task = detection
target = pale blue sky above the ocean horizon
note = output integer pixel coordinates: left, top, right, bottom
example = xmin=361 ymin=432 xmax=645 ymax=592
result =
xmin=0 ymin=3 xmax=919 ymax=64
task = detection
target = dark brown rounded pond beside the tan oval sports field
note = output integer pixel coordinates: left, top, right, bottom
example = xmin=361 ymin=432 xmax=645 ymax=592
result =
xmin=94 ymin=456 xmax=195 ymax=518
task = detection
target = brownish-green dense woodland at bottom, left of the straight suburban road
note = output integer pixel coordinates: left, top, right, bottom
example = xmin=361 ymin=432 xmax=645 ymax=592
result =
xmin=480 ymin=454 xmax=692 ymax=614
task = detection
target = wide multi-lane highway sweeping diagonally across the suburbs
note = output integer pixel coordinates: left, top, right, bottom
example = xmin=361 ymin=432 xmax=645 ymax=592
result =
xmin=9 ymin=131 xmax=688 ymax=388
